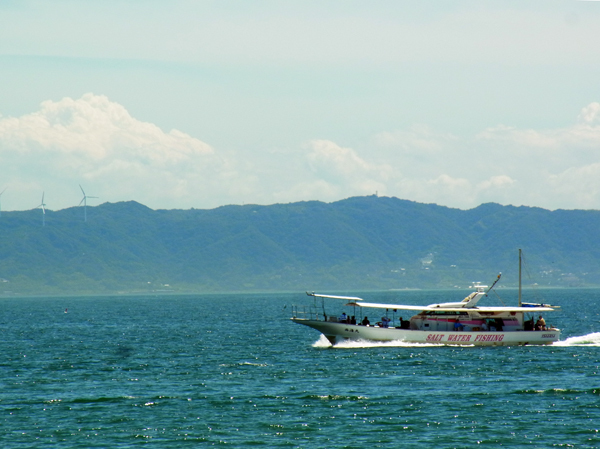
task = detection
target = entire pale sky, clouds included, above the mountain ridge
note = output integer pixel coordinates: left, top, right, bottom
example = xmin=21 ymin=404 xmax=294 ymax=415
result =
xmin=0 ymin=0 xmax=600 ymax=211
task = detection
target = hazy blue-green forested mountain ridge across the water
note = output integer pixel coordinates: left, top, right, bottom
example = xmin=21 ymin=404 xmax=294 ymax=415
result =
xmin=0 ymin=196 xmax=600 ymax=295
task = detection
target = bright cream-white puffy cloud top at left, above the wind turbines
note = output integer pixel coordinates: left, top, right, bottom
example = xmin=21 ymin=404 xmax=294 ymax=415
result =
xmin=0 ymin=93 xmax=213 ymax=160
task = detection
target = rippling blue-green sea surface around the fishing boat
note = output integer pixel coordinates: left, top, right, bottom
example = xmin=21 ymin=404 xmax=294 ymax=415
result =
xmin=0 ymin=290 xmax=600 ymax=448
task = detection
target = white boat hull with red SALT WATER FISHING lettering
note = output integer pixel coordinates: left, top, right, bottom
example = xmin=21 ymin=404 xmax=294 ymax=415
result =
xmin=292 ymin=318 xmax=560 ymax=346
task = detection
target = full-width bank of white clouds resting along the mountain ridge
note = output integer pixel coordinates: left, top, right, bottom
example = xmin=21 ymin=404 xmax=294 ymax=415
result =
xmin=0 ymin=94 xmax=600 ymax=210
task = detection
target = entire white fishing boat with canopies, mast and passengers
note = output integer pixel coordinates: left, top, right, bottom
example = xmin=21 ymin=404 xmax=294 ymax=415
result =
xmin=291 ymin=252 xmax=560 ymax=346
